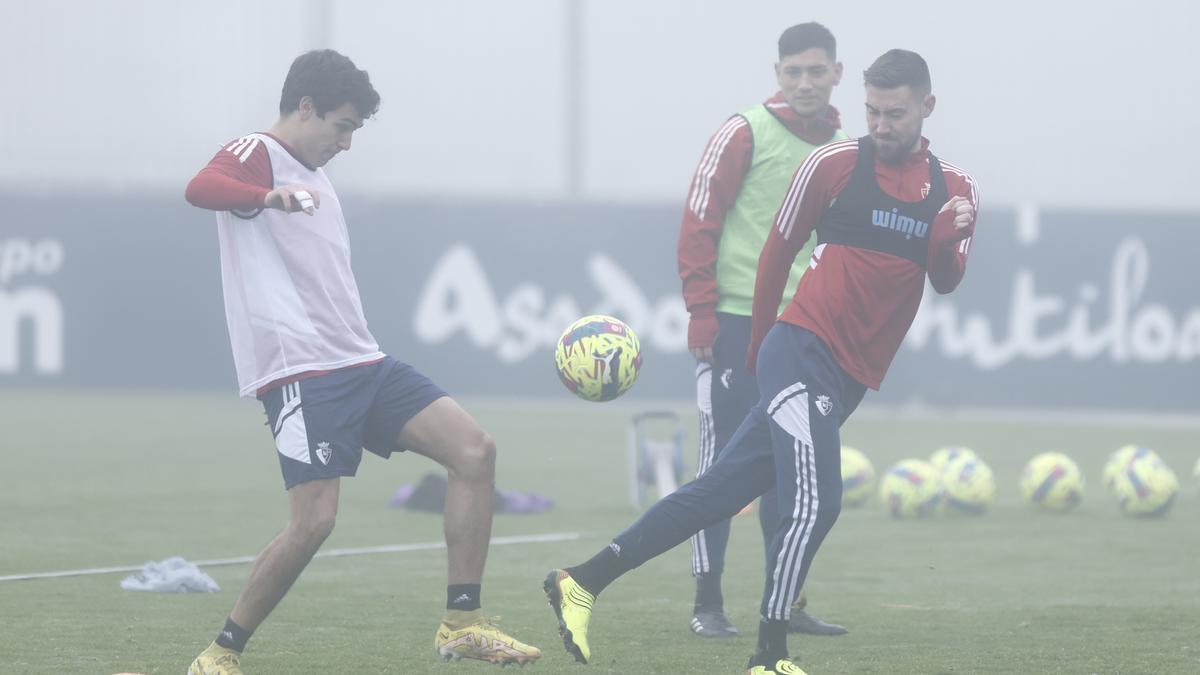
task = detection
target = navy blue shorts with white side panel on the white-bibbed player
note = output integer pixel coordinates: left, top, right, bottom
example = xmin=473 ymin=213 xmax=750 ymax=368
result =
xmin=258 ymin=357 xmax=446 ymax=489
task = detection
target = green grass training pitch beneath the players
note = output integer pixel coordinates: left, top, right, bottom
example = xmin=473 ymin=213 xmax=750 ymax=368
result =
xmin=0 ymin=392 xmax=1200 ymax=675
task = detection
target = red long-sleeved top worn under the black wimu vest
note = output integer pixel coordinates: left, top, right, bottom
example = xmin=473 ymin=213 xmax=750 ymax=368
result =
xmin=748 ymin=138 xmax=979 ymax=389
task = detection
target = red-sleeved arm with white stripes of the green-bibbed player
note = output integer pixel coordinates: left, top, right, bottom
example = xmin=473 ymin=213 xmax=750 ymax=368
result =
xmin=677 ymin=115 xmax=754 ymax=363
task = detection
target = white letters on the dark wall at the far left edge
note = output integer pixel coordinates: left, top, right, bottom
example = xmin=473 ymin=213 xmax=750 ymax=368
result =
xmin=0 ymin=239 xmax=64 ymax=375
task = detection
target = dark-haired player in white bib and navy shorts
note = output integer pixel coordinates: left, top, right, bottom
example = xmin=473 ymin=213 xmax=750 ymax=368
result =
xmin=187 ymin=49 xmax=541 ymax=675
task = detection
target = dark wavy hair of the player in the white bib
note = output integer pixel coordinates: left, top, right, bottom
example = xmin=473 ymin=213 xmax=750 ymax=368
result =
xmin=280 ymin=49 xmax=379 ymax=119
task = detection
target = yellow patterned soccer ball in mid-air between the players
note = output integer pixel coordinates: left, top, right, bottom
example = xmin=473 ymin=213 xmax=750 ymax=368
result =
xmin=554 ymin=315 xmax=642 ymax=401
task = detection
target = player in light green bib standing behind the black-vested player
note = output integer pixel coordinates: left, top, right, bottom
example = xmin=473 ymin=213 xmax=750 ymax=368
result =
xmin=678 ymin=23 xmax=847 ymax=638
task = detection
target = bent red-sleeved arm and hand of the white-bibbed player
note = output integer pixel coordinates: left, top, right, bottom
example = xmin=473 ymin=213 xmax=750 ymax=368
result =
xmin=185 ymin=136 xmax=320 ymax=214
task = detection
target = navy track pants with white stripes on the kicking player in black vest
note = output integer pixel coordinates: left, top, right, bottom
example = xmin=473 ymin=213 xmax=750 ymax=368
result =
xmin=613 ymin=323 xmax=866 ymax=620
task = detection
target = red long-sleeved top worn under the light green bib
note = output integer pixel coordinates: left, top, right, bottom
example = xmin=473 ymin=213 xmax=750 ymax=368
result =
xmin=677 ymin=92 xmax=841 ymax=346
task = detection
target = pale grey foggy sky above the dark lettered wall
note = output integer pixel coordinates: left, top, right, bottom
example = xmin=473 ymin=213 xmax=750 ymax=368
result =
xmin=0 ymin=0 xmax=1200 ymax=207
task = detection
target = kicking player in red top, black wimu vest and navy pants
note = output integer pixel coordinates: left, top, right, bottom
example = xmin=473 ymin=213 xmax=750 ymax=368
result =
xmin=545 ymin=49 xmax=978 ymax=675
